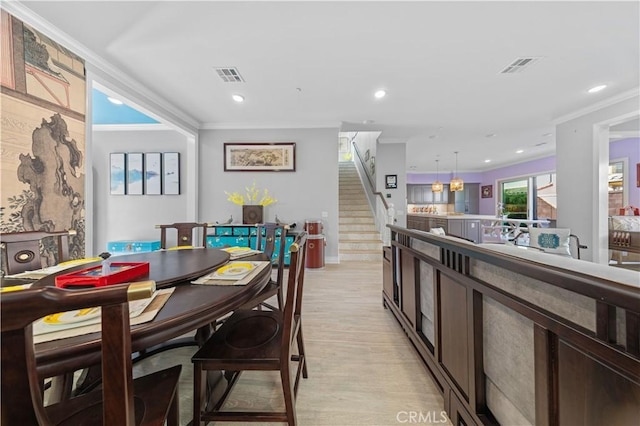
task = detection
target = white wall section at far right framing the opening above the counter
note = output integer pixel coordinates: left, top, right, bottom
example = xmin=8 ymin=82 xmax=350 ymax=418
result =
xmin=556 ymin=94 xmax=640 ymax=263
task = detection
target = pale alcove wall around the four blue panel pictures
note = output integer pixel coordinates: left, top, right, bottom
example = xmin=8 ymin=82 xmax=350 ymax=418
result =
xmin=87 ymin=130 xmax=194 ymax=257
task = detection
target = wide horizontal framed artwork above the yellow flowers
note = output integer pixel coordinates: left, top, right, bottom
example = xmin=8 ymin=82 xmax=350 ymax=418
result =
xmin=224 ymin=142 xmax=296 ymax=172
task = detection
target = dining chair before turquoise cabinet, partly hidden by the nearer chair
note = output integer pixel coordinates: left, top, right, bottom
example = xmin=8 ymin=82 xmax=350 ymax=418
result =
xmin=242 ymin=222 xmax=289 ymax=310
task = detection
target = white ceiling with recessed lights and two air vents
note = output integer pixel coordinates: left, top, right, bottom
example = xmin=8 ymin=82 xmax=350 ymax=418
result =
xmin=10 ymin=1 xmax=640 ymax=172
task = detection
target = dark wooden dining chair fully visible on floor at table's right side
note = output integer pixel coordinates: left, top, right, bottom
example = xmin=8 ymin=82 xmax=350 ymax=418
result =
xmin=191 ymin=232 xmax=308 ymax=426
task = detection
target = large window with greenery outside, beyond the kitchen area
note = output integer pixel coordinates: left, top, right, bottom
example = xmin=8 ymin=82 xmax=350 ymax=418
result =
xmin=499 ymin=173 xmax=558 ymax=220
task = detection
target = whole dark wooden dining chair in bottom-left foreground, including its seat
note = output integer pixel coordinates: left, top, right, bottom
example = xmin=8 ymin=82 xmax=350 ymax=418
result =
xmin=0 ymin=281 xmax=182 ymax=426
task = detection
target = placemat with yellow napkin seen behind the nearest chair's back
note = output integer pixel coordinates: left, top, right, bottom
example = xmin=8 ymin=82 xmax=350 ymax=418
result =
xmin=33 ymin=287 xmax=175 ymax=343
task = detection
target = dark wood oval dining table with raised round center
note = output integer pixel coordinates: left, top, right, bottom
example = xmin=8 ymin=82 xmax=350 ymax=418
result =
xmin=24 ymin=248 xmax=271 ymax=378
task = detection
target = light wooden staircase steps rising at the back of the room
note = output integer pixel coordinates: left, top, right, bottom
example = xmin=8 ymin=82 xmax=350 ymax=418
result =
xmin=338 ymin=161 xmax=382 ymax=262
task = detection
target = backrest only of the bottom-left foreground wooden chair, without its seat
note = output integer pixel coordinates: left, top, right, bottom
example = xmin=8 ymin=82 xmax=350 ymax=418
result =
xmin=0 ymin=281 xmax=155 ymax=425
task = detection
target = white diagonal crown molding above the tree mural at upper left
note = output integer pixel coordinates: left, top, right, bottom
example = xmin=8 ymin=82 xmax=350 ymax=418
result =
xmin=2 ymin=1 xmax=199 ymax=132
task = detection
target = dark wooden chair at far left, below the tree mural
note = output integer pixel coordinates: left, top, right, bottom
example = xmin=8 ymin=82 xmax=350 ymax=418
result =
xmin=0 ymin=230 xmax=77 ymax=275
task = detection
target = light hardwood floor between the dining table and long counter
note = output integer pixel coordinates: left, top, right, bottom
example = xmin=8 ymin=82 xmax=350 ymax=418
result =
xmin=134 ymin=262 xmax=450 ymax=426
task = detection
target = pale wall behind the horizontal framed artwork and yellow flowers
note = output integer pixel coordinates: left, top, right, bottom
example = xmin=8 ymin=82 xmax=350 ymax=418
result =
xmin=199 ymin=128 xmax=339 ymax=263
